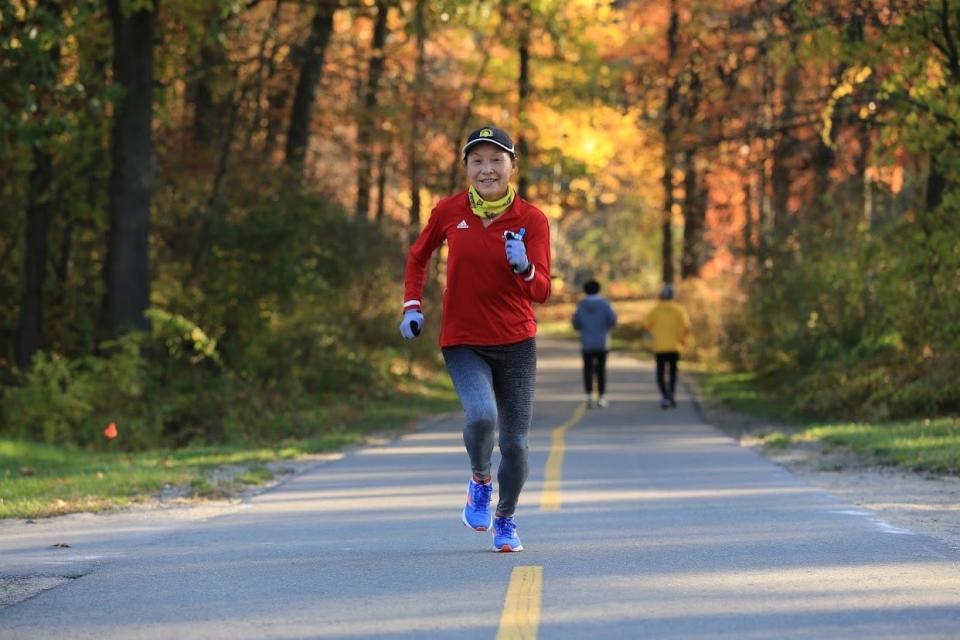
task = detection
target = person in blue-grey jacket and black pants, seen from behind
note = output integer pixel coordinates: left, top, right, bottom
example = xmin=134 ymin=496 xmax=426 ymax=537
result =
xmin=573 ymin=280 xmax=617 ymax=408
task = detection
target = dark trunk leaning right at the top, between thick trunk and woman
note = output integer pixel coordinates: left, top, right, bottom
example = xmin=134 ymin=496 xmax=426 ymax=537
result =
xmin=283 ymin=0 xmax=340 ymax=177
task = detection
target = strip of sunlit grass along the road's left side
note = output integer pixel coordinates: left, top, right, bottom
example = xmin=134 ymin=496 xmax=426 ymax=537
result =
xmin=0 ymin=385 xmax=458 ymax=518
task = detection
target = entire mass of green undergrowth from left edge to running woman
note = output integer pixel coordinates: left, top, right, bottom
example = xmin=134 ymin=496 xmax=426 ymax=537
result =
xmin=0 ymin=170 xmax=439 ymax=449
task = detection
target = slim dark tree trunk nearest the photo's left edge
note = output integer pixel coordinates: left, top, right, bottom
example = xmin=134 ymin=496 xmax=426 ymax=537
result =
xmin=16 ymin=145 xmax=53 ymax=369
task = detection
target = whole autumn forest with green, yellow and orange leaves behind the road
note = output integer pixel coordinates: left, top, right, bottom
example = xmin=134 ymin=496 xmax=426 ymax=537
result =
xmin=0 ymin=0 xmax=960 ymax=460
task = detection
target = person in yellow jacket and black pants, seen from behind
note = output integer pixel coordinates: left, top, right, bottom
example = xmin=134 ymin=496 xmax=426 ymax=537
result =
xmin=643 ymin=284 xmax=691 ymax=409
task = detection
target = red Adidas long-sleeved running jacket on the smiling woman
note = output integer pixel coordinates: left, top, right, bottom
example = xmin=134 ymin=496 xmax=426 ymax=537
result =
xmin=403 ymin=191 xmax=550 ymax=347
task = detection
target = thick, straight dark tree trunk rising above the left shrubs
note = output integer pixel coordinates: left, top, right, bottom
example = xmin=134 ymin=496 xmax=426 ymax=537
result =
xmin=104 ymin=0 xmax=156 ymax=336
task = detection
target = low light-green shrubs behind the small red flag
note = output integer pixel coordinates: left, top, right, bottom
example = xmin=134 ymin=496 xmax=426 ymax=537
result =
xmin=3 ymin=309 xmax=235 ymax=449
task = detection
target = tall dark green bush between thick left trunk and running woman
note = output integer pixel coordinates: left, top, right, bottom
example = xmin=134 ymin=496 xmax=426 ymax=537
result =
xmin=155 ymin=172 xmax=416 ymax=395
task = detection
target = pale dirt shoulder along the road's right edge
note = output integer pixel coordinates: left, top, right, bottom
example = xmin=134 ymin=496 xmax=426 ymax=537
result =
xmin=687 ymin=379 xmax=960 ymax=550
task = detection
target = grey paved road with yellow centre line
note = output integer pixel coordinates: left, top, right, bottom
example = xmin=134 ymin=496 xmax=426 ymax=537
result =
xmin=0 ymin=341 xmax=960 ymax=640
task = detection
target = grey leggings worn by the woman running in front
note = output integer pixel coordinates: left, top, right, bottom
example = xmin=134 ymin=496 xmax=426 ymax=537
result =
xmin=443 ymin=338 xmax=537 ymax=516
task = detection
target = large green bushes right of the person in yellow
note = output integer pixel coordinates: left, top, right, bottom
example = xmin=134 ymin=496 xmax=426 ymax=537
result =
xmin=725 ymin=198 xmax=960 ymax=420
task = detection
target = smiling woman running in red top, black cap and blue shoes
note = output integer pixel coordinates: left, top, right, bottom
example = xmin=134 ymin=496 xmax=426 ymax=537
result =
xmin=400 ymin=126 xmax=550 ymax=551
